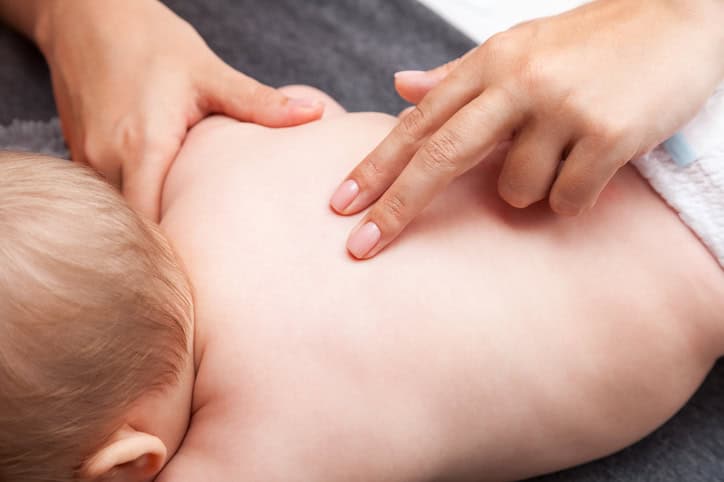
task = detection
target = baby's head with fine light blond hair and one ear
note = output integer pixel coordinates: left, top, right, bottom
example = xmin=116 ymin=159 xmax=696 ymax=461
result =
xmin=0 ymin=153 xmax=193 ymax=482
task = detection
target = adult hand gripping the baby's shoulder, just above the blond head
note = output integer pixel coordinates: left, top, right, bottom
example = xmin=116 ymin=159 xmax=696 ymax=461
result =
xmin=36 ymin=0 xmax=323 ymax=219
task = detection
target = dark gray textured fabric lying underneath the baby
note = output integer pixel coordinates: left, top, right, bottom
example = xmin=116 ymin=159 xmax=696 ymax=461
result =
xmin=0 ymin=0 xmax=724 ymax=482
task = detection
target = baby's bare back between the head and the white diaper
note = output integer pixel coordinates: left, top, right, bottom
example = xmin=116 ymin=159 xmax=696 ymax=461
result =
xmin=157 ymin=114 xmax=724 ymax=482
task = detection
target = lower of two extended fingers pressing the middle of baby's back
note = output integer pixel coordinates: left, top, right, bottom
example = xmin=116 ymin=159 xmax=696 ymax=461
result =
xmin=347 ymin=88 xmax=524 ymax=259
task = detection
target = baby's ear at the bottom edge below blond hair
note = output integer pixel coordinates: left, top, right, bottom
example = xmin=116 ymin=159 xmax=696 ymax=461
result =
xmin=81 ymin=425 xmax=166 ymax=482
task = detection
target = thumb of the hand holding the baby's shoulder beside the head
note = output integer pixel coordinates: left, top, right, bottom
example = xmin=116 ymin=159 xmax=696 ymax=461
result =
xmin=201 ymin=62 xmax=324 ymax=127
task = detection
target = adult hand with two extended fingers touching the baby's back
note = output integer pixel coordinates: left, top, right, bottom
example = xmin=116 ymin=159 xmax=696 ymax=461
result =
xmin=331 ymin=0 xmax=724 ymax=259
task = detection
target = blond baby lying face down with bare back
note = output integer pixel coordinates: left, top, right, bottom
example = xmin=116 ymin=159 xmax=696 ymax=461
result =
xmin=0 ymin=86 xmax=724 ymax=482
